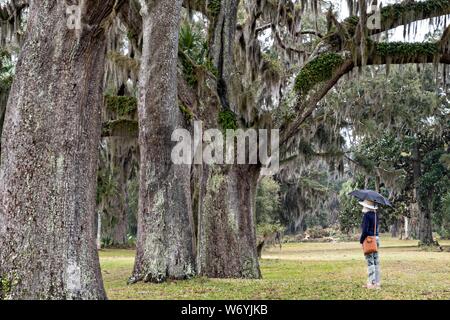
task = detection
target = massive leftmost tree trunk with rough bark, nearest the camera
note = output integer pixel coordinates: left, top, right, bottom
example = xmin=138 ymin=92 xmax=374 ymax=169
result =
xmin=0 ymin=0 xmax=116 ymax=299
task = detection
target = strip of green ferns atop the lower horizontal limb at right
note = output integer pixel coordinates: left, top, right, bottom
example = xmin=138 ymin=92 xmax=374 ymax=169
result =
xmin=374 ymin=42 xmax=439 ymax=57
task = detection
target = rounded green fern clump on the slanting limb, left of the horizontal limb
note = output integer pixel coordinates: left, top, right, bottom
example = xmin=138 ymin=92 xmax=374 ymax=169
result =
xmin=295 ymin=52 xmax=344 ymax=95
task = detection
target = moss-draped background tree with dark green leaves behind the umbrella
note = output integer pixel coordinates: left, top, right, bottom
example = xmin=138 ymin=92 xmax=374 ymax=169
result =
xmin=326 ymin=66 xmax=448 ymax=244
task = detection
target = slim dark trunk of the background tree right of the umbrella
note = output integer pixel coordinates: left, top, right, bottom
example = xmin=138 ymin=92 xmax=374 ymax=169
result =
xmin=413 ymin=143 xmax=434 ymax=245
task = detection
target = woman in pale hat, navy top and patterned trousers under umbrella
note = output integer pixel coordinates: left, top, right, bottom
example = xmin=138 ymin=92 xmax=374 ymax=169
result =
xmin=359 ymin=200 xmax=381 ymax=289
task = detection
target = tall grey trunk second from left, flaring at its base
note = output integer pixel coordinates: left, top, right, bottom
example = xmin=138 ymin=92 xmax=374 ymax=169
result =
xmin=130 ymin=0 xmax=195 ymax=282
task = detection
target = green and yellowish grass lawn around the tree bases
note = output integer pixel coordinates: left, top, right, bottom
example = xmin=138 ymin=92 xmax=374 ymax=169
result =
xmin=100 ymin=238 xmax=450 ymax=300
